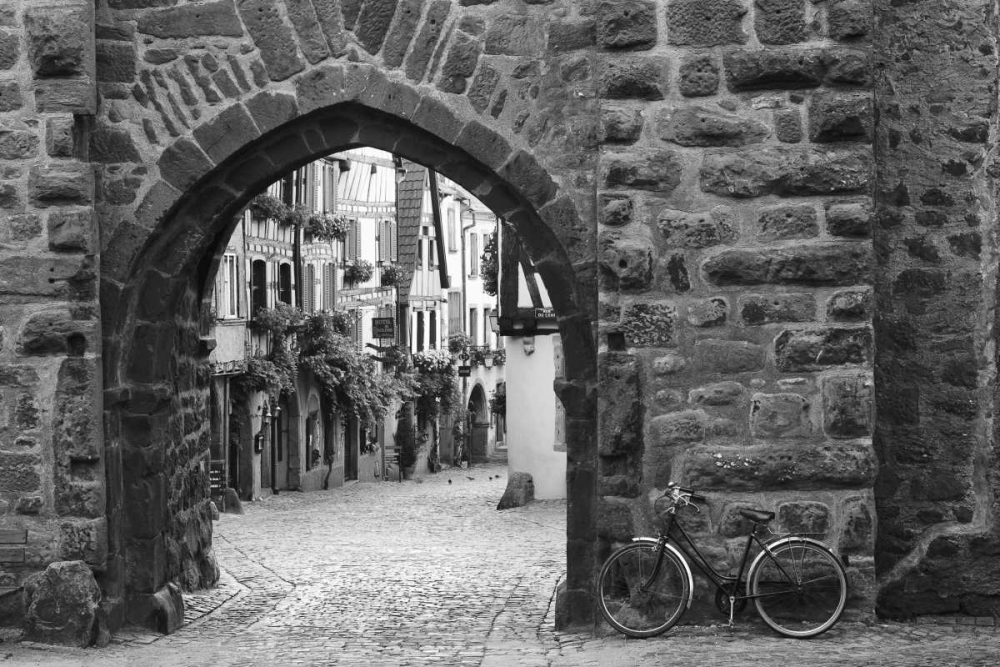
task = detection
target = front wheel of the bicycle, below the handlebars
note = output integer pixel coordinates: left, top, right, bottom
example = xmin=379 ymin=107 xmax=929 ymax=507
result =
xmin=597 ymin=542 xmax=691 ymax=637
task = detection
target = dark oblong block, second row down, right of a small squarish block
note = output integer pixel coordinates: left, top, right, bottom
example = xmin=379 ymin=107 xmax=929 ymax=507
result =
xmin=723 ymin=49 xmax=827 ymax=92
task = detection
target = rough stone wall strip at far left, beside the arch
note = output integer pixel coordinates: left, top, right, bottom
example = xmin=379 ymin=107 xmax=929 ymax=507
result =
xmin=0 ymin=0 xmax=108 ymax=619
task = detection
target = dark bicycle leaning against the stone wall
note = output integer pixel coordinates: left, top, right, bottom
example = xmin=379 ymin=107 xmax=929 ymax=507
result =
xmin=597 ymin=483 xmax=847 ymax=639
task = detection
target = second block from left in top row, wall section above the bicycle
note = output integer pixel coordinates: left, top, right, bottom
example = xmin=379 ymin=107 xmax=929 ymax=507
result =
xmin=667 ymin=0 xmax=749 ymax=46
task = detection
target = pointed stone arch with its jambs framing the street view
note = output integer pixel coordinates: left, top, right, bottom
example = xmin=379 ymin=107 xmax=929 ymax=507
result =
xmin=102 ymin=90 xmax=596 ymax=623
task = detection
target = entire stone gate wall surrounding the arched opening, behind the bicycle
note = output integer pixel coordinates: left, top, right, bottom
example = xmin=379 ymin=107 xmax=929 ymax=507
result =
xmin=0 ymin=0 xmax=1000 ymax=640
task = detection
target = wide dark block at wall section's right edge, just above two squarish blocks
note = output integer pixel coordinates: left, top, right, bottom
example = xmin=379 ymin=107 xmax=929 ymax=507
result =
xmin=774 ymin=328 xmax=872 ymax=373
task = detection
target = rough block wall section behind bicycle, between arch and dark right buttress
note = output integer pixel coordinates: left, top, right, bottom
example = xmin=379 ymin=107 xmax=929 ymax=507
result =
xmin=594 ymin=0 xmax=876 ymax=613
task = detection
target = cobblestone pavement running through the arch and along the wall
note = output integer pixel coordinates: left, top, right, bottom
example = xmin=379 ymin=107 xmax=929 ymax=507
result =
xmin=0 ymin=466 xmax=1000 ymax=667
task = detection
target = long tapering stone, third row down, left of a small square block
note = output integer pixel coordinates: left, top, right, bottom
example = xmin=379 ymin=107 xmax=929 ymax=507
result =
xmin=656 ymin=106 xmax=770 ymax=146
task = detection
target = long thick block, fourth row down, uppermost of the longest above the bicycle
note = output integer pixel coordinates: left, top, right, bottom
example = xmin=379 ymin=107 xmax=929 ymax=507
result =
xmin=700 ymin=148 xmax=871 ymax=198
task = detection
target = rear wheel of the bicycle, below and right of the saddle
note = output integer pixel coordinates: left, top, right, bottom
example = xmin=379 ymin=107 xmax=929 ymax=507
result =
xmin=749 ymin=537 xmax=847 ymax=638
